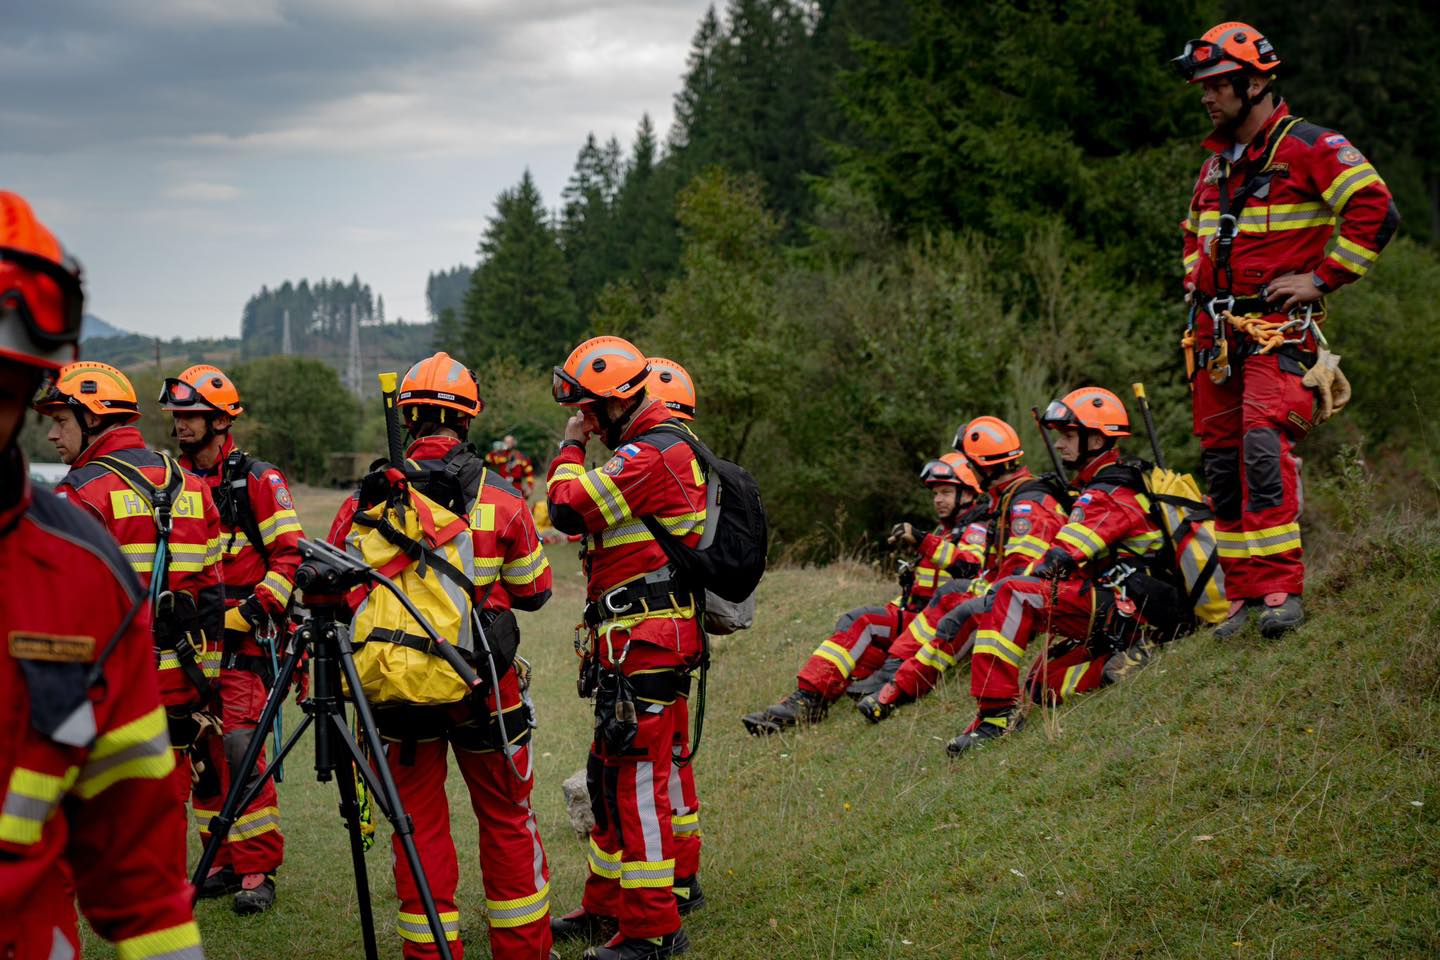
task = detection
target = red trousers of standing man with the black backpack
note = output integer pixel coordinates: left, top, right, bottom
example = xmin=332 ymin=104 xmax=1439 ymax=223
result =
xmin=582 ymin=617 xmax=700 ymax=937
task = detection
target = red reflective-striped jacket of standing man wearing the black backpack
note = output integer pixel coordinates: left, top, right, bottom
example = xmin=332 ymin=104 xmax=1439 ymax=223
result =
xmin=546 ymin=400 xmax=706 ymax=600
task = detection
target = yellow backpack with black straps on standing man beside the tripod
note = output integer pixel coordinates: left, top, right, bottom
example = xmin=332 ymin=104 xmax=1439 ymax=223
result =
xmin=346 ymin=485 xmax=475 ymax=705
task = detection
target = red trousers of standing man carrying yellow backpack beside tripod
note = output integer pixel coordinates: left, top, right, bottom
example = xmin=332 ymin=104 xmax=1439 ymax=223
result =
xmin=379 ymin=671 xmax=550 ymax=960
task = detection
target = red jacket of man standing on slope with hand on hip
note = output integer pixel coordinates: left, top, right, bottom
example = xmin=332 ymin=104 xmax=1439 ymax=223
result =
xmin=1182 ymin=104 xmax=1400 ymax=308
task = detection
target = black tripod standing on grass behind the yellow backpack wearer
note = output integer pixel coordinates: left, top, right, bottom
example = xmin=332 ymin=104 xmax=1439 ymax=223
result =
xmin=192 ymin=540 xmax=460 ymax=960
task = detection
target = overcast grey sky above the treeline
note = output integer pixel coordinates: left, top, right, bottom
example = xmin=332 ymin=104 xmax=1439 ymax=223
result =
xmin=0 ymin=0 xmax=708 ymax=337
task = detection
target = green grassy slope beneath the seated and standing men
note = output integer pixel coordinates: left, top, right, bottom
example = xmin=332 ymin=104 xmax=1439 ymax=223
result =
xmin=92 ymin=502 xmax=1440 ymax=959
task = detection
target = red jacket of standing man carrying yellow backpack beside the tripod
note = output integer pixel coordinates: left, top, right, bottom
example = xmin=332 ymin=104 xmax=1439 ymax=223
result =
xmin=330 ymin=436 xmax=552 ymax=612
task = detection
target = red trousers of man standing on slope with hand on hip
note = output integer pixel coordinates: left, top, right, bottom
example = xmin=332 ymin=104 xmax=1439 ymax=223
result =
xmin=1191 ymin=344 xmax=1315 ymax=600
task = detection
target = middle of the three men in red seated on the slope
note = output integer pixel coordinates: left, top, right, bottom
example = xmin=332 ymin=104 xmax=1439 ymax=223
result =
xmin=860 ymin=416 xmax=1066 ymax=723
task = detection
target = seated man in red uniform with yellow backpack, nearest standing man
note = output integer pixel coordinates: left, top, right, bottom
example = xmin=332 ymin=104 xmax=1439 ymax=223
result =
xmin=946 ymin=387 xmax=1181 ymax=757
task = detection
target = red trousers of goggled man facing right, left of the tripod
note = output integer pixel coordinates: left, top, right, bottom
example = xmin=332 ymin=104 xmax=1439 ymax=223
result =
xmin=186 ymin=669 xmax=285 ymax=877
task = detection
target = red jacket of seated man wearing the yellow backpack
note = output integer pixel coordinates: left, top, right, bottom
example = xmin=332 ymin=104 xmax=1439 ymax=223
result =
xmin=1053 ymin=450 xmax=1165 ymax=577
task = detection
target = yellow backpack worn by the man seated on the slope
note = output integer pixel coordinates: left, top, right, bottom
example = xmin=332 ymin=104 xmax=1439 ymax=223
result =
xmin=1140 ymin=463 xmax=1230 ymax=623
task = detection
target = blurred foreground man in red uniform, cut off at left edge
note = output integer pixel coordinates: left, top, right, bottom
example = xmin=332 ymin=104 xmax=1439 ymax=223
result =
xmin=0 ymin=191 xmax=204 ymax=960
